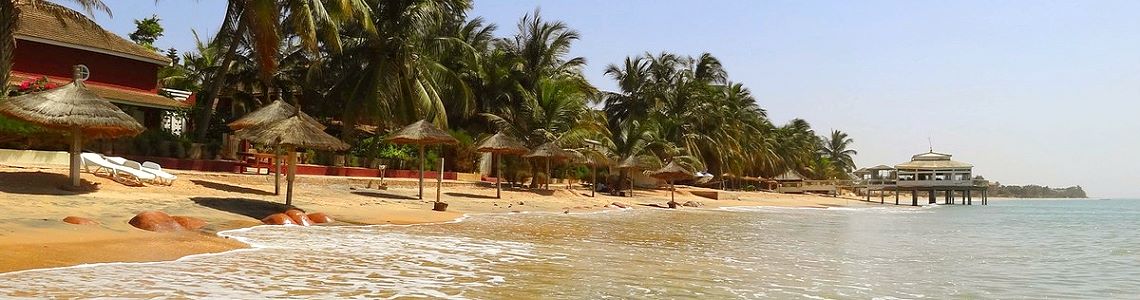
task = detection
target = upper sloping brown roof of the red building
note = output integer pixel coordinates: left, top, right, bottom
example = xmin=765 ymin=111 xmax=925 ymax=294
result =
xmin=15 ymin=5 xmax=171 ymax=65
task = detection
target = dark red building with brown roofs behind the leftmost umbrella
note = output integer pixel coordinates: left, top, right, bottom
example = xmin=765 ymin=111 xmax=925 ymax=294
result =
xmin=10 ymin=6 xmax=193 ymax=129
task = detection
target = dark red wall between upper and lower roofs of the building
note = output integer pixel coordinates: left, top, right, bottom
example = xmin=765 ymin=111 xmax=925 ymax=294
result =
xmin=13 ymin=40 xmax=160 ymax=92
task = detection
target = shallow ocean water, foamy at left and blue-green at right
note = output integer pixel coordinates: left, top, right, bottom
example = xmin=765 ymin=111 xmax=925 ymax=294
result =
xmin=0 ymin=200 xmax=1140 ymax=299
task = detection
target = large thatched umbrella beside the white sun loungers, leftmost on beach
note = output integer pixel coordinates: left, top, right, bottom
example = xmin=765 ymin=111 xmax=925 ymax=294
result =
xmin=0 ymin=66 xmax=145 ymax=187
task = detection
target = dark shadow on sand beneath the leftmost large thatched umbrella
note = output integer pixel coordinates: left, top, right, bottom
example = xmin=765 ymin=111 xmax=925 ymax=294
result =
xmin=0 ymin=172 xmax=99 ymax=195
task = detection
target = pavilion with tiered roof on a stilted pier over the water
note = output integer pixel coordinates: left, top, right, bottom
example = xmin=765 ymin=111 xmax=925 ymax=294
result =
xmin=853 ymin=149 xmax=990 ymax=206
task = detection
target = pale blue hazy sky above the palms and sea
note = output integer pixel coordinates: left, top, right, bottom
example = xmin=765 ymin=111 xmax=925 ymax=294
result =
xmin=64 ymin=0 xmax=1140 ymax=197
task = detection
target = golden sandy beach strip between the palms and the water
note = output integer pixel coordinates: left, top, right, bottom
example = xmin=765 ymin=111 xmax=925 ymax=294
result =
xmin=0 ymin=165 xmax=879 ymax=273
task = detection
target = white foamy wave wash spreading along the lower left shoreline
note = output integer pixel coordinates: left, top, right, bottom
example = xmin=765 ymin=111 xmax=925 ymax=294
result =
xmin=0 ymin=219 xmax=537 ymax=299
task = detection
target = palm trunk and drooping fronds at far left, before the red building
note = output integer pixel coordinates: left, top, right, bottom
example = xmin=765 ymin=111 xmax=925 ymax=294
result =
xmin=0 ymin=0 xmax=111 ymax=98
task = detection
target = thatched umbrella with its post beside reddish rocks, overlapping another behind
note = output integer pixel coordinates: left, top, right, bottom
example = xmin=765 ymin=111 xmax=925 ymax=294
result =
xmin=237 ymin=112 xmax=349 ymax=205
